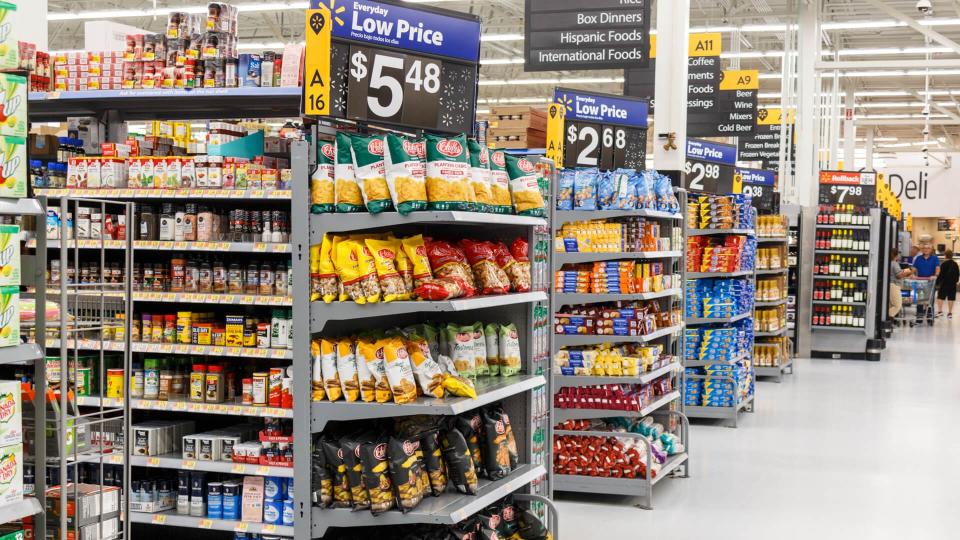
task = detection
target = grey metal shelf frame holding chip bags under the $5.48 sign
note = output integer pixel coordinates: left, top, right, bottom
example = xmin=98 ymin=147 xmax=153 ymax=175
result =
xmin=300 ymin=142 xmax=556 ymax=539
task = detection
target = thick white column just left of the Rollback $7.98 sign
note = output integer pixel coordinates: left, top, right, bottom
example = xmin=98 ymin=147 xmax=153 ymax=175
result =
xmin=796 ymin=0 xmax=821 ymax=206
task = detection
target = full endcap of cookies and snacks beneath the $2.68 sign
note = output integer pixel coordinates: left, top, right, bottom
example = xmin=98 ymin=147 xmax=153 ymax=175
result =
xmin=551 ymin=169 xmax=688 ymax=508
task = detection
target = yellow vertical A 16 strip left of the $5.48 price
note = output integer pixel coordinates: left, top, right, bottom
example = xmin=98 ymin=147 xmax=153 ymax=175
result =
xmin=303 ymin=4 xmax=333 ymax=115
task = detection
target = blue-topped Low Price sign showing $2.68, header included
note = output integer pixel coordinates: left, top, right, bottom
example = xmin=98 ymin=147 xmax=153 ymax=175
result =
xmin=548 ymin=88 xmax=650 ymax=170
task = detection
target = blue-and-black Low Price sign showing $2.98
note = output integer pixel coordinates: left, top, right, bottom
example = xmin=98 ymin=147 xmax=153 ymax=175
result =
xmin=683 ymin=139 xmax=741 ymax=194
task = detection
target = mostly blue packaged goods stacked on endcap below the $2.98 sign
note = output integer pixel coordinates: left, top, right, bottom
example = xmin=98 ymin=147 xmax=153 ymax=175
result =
xmin=683 ymin=194 xmax=758 ymax=426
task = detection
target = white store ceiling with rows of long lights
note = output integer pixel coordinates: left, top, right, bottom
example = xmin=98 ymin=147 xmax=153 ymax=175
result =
xmin=49 ymin=0 xmax=960 ymax=151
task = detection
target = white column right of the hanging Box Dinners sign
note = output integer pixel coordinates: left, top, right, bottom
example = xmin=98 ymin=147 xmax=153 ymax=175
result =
xmin=653 ymin=0 xmax=690 ymax=171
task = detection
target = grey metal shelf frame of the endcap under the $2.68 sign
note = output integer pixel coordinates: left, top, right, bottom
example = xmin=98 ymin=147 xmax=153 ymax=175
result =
xmin=549 ymin=183 xmax=689 ymax=509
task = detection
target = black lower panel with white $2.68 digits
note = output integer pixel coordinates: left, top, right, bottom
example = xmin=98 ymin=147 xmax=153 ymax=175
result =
xmin=564 ymin=120 xmax=646 ymax=170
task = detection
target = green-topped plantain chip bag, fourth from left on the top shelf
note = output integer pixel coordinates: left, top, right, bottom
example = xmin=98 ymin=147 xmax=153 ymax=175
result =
xmin=384 ymin=133 xmax=427 ymax=215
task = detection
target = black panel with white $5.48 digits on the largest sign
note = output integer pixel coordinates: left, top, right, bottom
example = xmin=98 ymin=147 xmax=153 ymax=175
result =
xmin=347 ymin=45 xmax=443 ymax=128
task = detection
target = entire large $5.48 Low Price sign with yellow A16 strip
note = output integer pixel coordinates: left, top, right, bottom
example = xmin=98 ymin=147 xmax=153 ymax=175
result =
xmin=303 ymin=0 xmax=480 ymax=133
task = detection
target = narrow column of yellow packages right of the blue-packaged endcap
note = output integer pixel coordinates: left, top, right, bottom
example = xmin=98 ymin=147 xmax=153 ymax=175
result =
xmin=753 ymin=214 xmax=793 ymax=382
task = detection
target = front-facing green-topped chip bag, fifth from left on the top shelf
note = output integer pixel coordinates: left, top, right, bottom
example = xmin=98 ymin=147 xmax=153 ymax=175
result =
xmin=426 ymin=134 xmax=475 ymax=211
